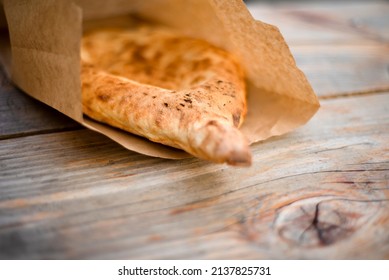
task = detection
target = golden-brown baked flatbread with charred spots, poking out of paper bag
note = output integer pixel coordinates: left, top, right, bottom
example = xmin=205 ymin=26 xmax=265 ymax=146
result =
xmin=81 ymin=27 xmax=251 ymax=165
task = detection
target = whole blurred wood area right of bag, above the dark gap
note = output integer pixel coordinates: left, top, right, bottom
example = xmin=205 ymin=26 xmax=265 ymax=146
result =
xmin=248 ymin=1 xmax=389 ymax=96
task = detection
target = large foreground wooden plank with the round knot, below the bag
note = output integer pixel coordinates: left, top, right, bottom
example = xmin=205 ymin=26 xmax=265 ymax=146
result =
xmin=0 ymin=92 xmax=389 ymax=259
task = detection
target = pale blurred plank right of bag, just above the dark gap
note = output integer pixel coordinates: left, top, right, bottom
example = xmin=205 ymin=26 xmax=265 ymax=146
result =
xmin=291 ymin=44 xmax=389 ymax=97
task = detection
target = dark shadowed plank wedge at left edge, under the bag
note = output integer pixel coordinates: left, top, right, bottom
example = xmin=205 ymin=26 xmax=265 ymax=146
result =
xmin=0 ymin=65 xmax=81 ymax=139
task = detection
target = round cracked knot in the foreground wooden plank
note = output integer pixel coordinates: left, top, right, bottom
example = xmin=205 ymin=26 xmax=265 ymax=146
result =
xmin=275 ymin=197 xmax=378 ymax=247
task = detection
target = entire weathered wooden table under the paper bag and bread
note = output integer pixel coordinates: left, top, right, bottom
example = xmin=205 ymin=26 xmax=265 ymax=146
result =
xmin=0 ymin=0 xmax=389 ymax=259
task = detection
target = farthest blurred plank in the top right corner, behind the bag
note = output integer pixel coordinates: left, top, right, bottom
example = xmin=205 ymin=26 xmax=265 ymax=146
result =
xmin=248 ymin=0 xmax=389 ymax=45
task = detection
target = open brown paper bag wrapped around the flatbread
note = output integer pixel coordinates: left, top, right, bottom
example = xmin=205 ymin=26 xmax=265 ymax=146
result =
xmin=0 ymin=0 xmax=319 ymax=159
